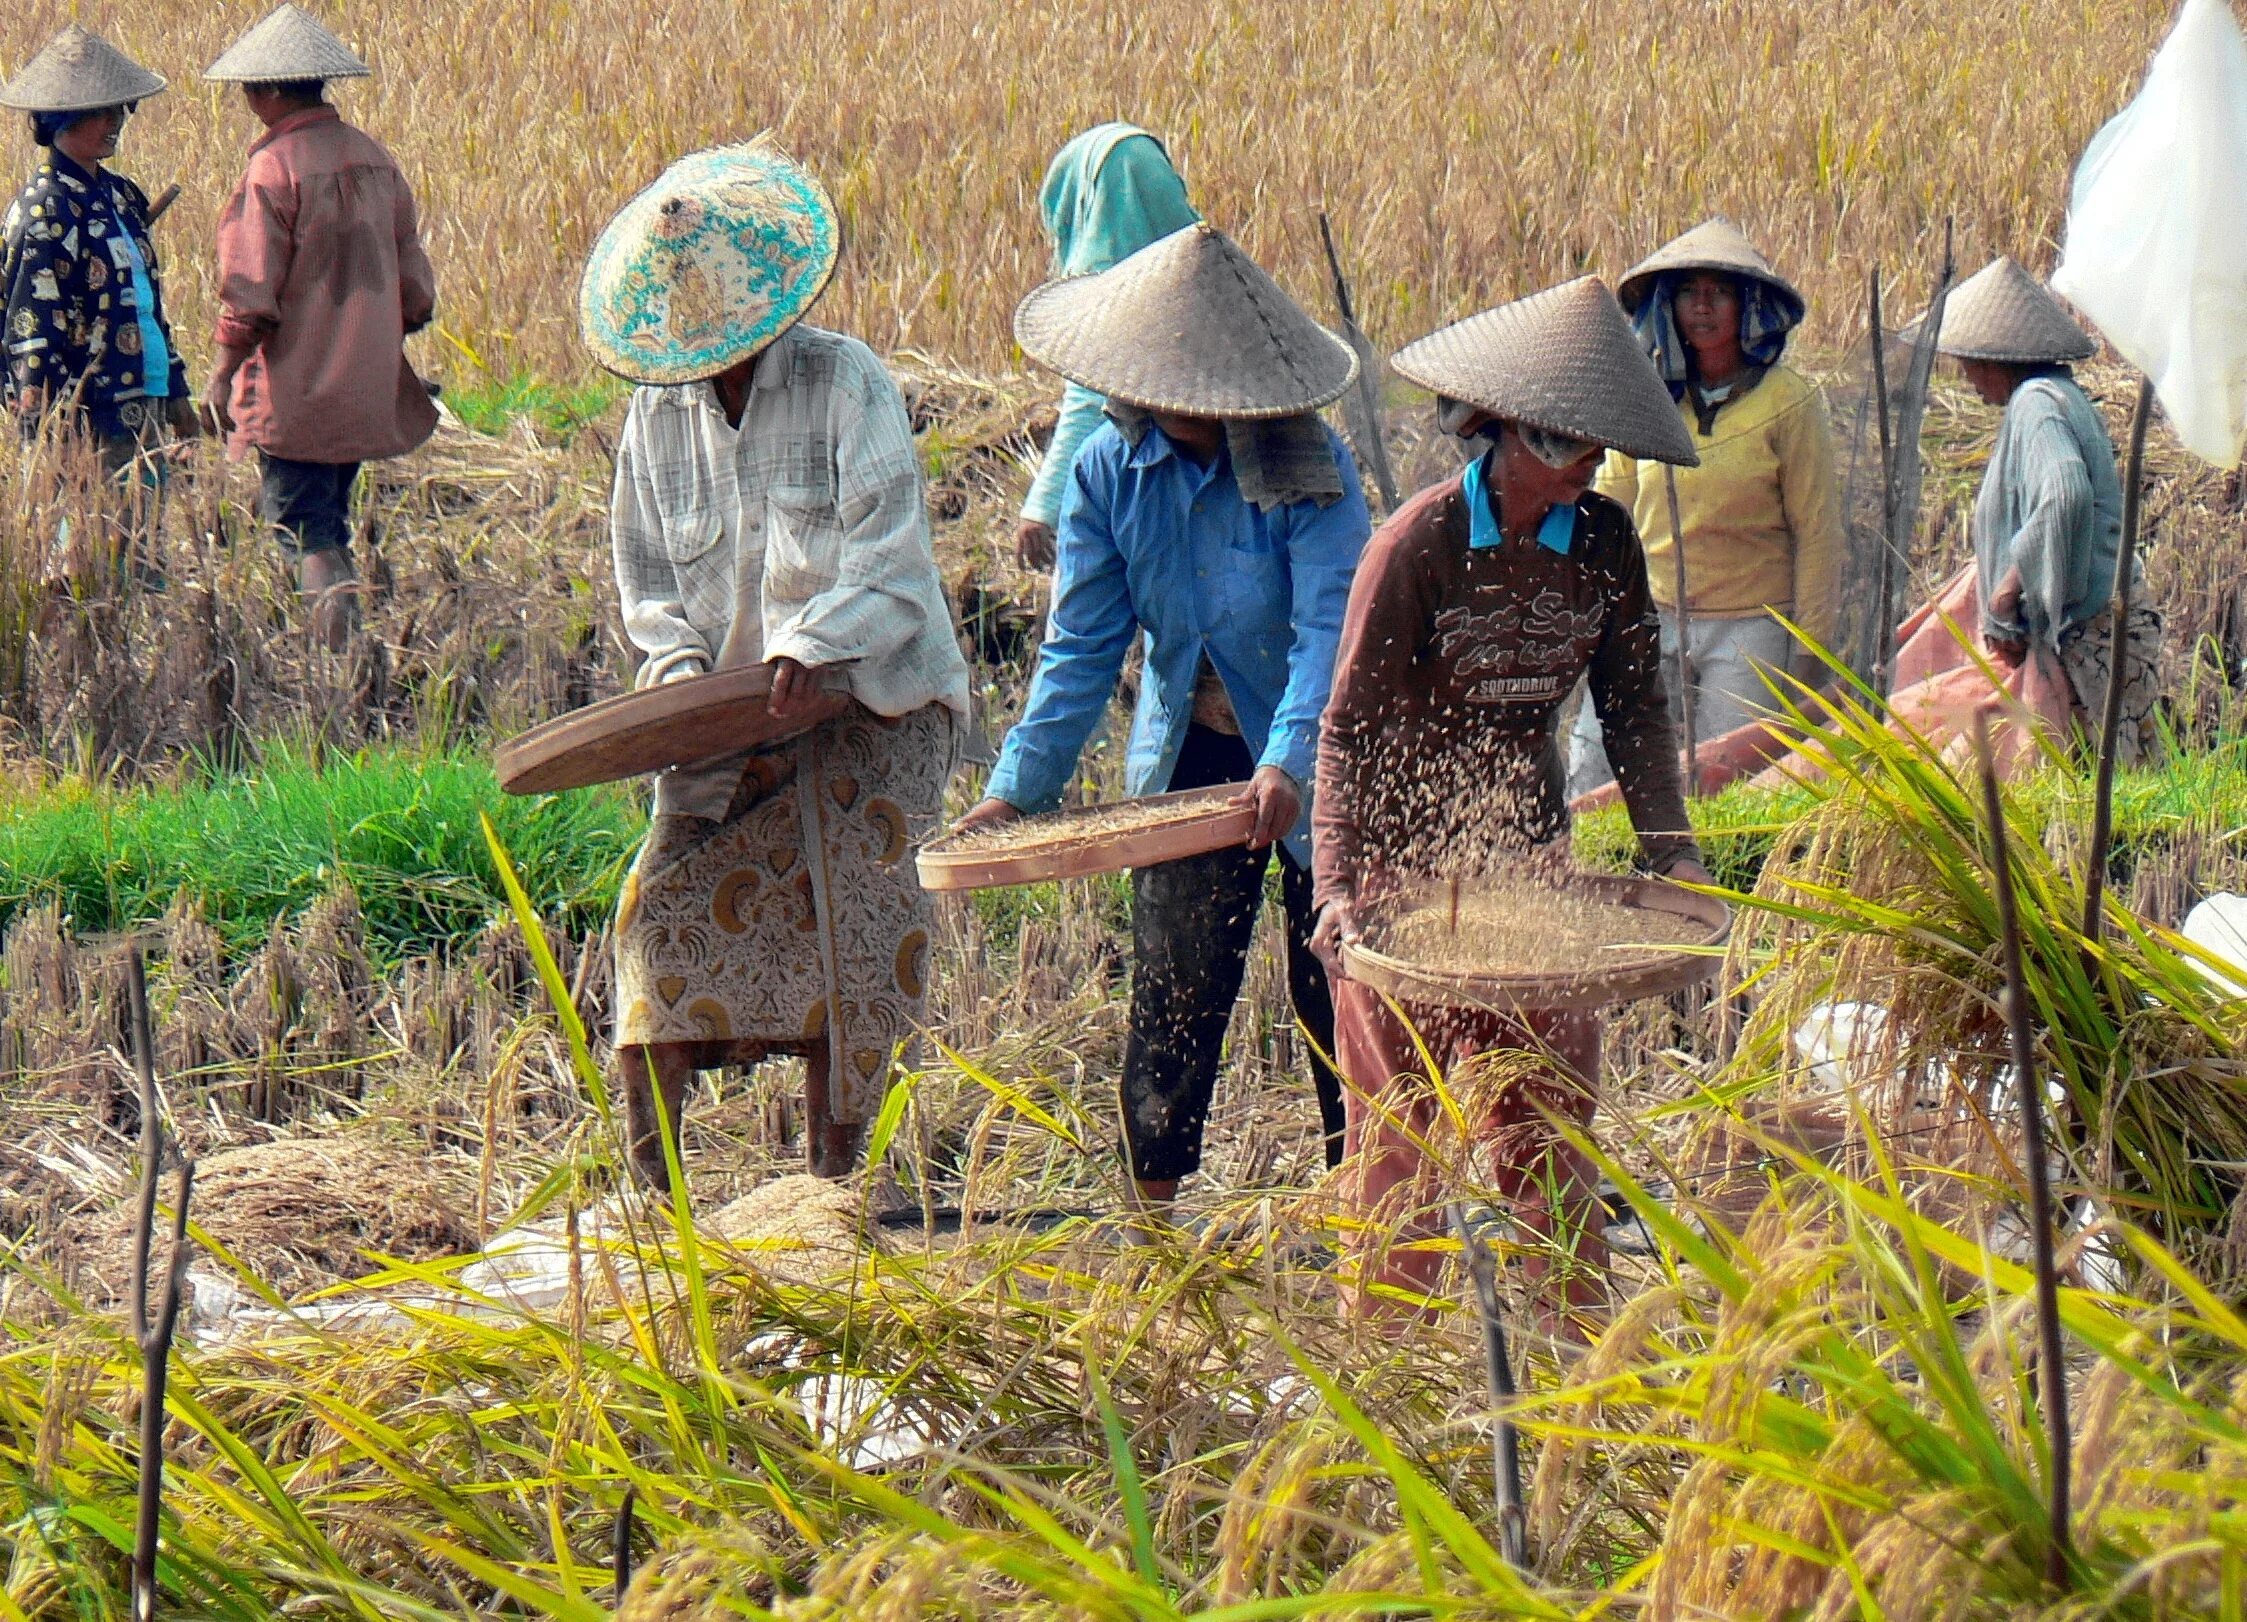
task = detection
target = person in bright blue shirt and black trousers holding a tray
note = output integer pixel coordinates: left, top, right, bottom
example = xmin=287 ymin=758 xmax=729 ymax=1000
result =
xmin=959 ymin=222 xmax=1371 ymax=1209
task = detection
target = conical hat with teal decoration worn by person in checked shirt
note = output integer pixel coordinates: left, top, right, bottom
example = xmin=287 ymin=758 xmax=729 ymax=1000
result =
xmin=577 ymin=137 xmax=843 ymax=384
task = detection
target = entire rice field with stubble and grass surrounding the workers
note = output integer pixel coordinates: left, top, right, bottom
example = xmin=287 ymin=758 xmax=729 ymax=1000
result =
xmin=13 ymin=0 xmax=2247 ymax=1622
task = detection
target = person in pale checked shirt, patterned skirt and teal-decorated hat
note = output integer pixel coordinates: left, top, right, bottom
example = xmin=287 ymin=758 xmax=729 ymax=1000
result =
xmin=577 ymin=142 xmax=968 ymax=1188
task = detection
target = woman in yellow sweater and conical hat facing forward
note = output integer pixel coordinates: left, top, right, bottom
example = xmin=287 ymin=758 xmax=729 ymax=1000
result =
xmin=1568 ymin=216 xmax=1843 ymax=795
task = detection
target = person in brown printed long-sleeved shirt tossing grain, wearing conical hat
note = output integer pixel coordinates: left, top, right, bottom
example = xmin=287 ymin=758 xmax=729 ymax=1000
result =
xmin=1314 ymin=276 xmax=1708 ymax=1316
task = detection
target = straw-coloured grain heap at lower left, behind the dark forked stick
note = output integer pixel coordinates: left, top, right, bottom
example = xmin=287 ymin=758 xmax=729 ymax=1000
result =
xmin=67 ymin=1132 xmax=479 ymax=1303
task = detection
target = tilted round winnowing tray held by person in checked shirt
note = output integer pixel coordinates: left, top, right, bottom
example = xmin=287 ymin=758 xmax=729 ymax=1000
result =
xmin=492 ymin=665 xmax=849 ymax=793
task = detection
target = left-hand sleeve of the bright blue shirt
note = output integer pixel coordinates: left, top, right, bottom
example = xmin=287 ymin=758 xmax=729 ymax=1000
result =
xmin=984 ymin=442 xmax=1139 ymax=813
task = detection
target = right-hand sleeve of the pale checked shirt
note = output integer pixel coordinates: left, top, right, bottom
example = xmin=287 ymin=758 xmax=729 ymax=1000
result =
xmin=764 ymin=359 xmax=935 ymax=665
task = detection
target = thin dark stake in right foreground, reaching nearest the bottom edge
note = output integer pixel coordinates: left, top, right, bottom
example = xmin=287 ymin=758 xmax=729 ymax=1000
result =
xmin=1973 ymin=710 xmax=2072 ymax=1588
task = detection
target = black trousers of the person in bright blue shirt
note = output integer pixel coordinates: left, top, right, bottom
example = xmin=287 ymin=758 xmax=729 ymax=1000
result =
xmin=1124 ymin=726 xmax=1344 ymax=1182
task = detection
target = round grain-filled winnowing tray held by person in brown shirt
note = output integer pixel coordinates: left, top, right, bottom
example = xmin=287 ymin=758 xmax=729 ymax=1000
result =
xmin=1341 ymin=874 xmax=1732 ymax=1013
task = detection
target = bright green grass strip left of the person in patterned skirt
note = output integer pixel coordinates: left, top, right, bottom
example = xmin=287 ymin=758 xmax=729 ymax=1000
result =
xmin=0 ymin=748 xmax=647 ymax=957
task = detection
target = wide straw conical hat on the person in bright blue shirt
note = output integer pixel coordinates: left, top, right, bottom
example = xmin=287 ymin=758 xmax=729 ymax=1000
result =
xmin=1013 ymin=222 xmax=1357 ymax=418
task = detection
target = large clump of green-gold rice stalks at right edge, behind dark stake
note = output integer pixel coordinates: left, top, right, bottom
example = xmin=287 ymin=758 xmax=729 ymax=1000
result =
xmin=1689 ymin=664 xmax=2247 ymax=1249
